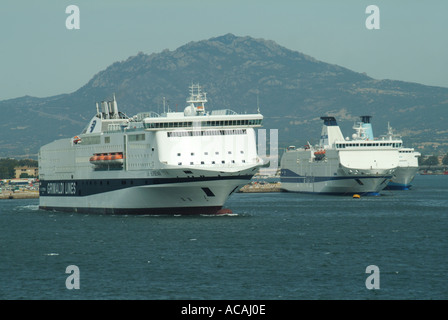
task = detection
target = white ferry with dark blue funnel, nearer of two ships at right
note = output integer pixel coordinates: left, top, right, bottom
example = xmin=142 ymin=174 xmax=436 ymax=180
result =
xmin=280 ymin=117 xmax=401 ymax=195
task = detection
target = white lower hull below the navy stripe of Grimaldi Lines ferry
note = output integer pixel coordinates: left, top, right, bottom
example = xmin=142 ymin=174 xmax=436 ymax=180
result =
xmin=39 ymin=176 xmax=250 ymax=215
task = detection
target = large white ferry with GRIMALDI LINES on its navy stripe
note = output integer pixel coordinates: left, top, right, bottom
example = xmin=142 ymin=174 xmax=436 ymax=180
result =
xmin=39 ymin=85 xmax=263 ymax=214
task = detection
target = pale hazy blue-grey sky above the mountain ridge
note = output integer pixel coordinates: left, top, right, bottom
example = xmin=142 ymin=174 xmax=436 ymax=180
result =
xmin=0 ymin=0 xmax=448 ymax=100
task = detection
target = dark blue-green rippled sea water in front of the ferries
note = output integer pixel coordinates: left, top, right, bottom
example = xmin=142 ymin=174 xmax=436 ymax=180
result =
xmin=0 ymin=176 xmax=448 ymax=300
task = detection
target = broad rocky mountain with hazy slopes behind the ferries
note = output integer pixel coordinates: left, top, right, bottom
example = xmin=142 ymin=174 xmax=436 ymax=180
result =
xmin=0 ymin=34 xmax=448 ymax=157
